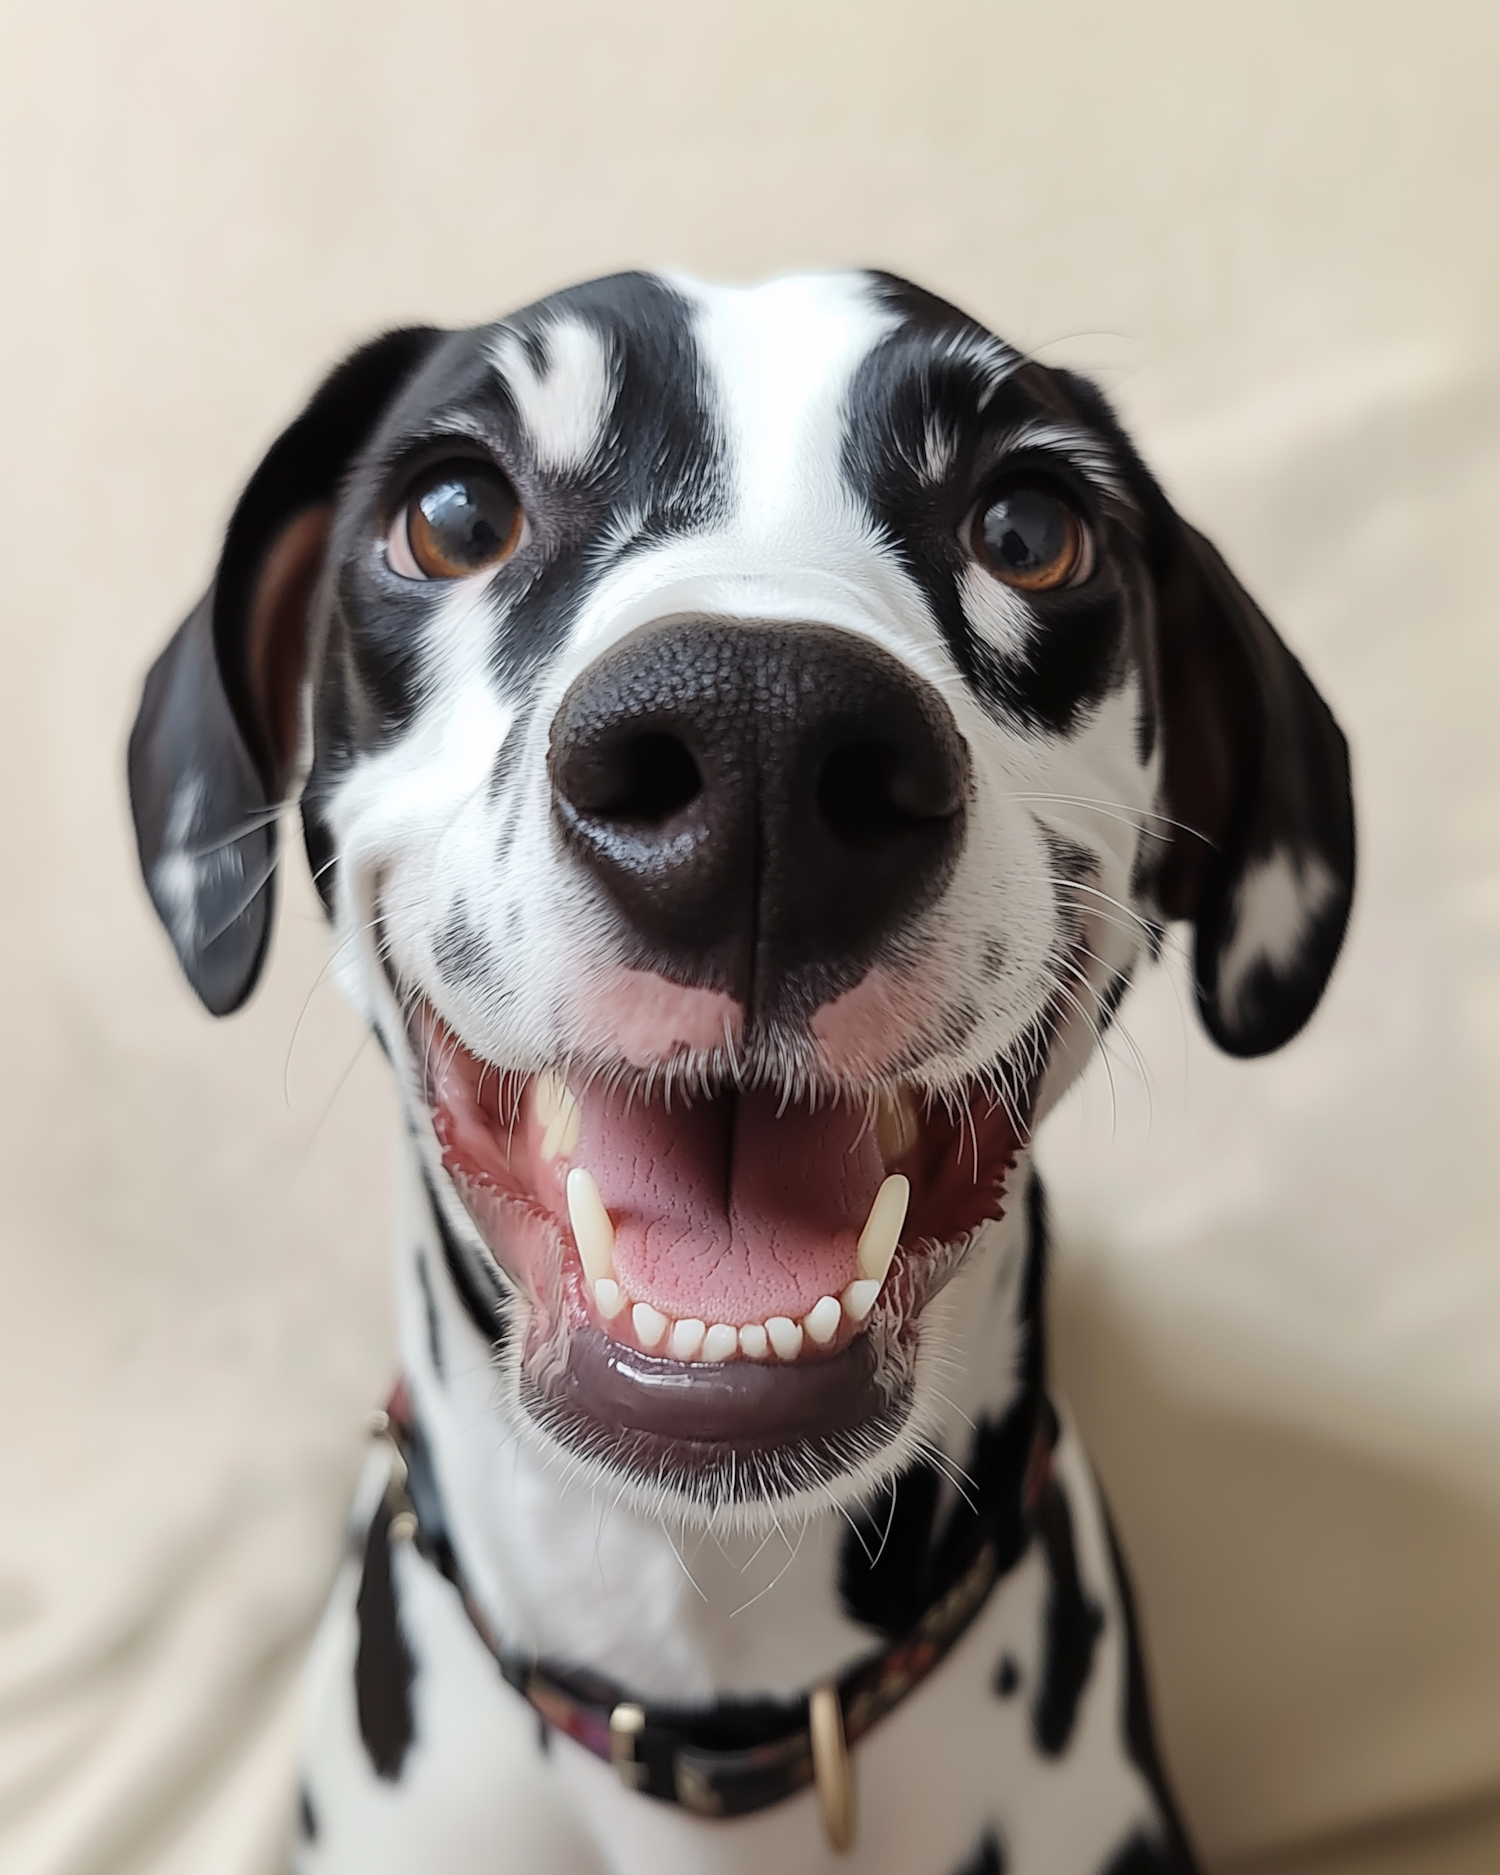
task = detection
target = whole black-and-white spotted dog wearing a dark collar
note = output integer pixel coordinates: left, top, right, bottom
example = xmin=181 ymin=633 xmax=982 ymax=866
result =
xmin=129 ymin=274 xmax=1354 ymax=1875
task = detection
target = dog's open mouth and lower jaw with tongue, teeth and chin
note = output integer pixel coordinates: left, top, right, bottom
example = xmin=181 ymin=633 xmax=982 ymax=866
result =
xmin=409 ymin=1003 xmax=1026 ymax=1511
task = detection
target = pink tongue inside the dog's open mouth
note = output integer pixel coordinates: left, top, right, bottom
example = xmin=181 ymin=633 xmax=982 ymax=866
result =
xmin=574 ymin=1091 xmax=885 ymax=1326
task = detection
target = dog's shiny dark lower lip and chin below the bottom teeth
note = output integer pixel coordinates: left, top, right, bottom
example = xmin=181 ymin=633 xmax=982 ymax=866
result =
xmin=525 ymin=1324 xmax=911 ymax=1500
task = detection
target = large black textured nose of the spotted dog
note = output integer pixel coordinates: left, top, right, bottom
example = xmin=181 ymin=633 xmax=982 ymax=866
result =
xmin=549 ymin=623 xmax=969 ymax=1013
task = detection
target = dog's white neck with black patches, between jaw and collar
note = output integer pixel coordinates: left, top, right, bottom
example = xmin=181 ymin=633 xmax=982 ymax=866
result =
xmin=398 ymin=1146 xmax=1044 ymax=1701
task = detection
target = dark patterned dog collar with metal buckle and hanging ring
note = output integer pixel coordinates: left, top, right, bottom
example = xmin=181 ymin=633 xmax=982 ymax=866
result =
xmin=373 ymin=1382 xmax=1056 ymax=1853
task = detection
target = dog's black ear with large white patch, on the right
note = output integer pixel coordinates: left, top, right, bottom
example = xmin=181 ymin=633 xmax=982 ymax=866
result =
xmin=1153 ymin=506 xmax=1354 ymax=1056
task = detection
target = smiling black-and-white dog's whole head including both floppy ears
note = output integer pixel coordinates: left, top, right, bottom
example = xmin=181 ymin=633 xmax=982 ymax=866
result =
xmin=131 ymin=276 xmax=1354 ymax=1506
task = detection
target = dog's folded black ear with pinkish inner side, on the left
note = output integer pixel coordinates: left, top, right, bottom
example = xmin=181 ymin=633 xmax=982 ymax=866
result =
xmin=128 ymin=326 xmax=441 ymax=1016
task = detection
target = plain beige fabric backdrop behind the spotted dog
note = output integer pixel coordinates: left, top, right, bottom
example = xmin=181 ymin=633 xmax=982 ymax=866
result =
xmin=0 ymin=0 xmax=1500 ymax=1875
